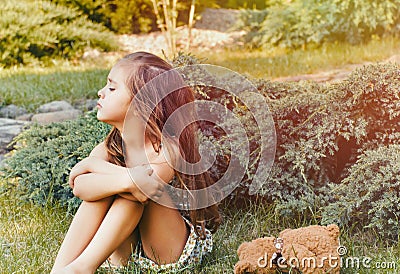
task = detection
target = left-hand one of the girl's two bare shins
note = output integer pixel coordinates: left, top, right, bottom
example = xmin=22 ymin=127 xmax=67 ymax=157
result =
xmin=51 ymin=197 xmax=114 ymax=273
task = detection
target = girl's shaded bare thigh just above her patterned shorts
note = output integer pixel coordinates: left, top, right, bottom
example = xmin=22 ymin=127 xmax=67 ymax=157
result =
xmin=139 ymin=201 xmax=189 ymax=264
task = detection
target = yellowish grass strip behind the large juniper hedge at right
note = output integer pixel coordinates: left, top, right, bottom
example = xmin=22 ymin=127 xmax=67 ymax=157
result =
xmin=193 ymin=37 xmax=400 ymax=79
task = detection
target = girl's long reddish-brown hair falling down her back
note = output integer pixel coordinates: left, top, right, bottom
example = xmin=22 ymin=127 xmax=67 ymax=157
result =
xmin=105 ymin=52 xmax=221 ymax=237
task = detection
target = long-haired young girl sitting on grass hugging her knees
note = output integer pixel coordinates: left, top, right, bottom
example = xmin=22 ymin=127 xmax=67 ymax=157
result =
xmin=51 ymin=52 xmax=220 ymax=273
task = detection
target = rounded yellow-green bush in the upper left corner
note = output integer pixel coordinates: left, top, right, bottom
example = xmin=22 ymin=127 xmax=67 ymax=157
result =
xmin=0 ymin=0 xmax=116 ymax=67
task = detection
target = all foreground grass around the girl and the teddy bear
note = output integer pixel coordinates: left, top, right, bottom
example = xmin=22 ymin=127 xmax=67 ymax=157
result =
xmin=0 ymin=181 xmax=400 ymax=274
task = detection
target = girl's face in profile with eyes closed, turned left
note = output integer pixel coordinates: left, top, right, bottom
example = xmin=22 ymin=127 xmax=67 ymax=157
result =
xmin=97 ymin=64 xmax=132 ymax=129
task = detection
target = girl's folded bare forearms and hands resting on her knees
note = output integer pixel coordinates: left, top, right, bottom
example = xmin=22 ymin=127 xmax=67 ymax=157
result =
xmin=70 ymin=143 xmax=173 ymax=202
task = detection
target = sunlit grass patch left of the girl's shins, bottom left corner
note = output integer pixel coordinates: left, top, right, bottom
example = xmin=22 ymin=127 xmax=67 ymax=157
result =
xmin=0 ymin=181 xmax=71 ymax=273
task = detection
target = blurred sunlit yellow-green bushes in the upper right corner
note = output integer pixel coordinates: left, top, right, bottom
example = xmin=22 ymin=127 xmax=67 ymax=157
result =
xmin=241 ymin=0 xmax=400 ymax=48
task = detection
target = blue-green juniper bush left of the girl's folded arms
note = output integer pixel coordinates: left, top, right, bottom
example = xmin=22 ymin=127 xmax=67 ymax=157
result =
xmin=4 ymin=111 xmax=110 ymax=210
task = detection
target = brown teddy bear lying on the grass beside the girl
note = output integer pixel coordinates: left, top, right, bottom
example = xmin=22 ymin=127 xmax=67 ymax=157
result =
xmin=235 ymin=224 xmax=340 ymax=274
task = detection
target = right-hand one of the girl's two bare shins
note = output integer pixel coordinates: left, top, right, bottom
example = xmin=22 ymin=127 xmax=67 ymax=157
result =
xmin=65 ymin=197 xmax=144 ymax=273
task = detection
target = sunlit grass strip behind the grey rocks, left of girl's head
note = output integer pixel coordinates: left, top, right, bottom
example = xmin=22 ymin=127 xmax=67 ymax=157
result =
xmin=0 ymin=55 xmax=120 ymax=112
